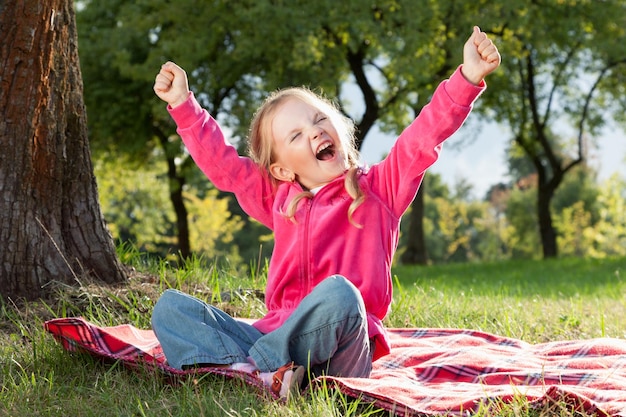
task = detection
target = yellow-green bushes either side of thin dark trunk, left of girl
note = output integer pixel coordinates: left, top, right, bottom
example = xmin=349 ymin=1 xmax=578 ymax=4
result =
xmin=95 ymin=155 xmax=243 ymax=264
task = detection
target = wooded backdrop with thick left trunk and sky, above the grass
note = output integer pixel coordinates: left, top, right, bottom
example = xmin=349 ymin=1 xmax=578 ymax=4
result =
xmin=0 ymin=0 xmax=626 ymax=298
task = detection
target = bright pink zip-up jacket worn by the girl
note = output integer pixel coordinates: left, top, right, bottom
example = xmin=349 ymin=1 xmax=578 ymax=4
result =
xmin=168 ymin=68 xmax=485 ymax=359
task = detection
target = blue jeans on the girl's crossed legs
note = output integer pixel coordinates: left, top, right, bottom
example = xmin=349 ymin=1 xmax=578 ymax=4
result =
xmin=152 ymin=275 xmax=373 ymax=377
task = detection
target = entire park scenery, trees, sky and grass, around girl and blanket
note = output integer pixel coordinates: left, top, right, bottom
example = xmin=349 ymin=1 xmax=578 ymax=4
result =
xmin=0 ymin=0 xmax=626 ymax=417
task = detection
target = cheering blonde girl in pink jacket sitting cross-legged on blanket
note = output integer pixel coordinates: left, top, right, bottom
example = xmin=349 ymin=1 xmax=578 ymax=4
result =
xmin=152 ymin=27 xmax=500 ymax=398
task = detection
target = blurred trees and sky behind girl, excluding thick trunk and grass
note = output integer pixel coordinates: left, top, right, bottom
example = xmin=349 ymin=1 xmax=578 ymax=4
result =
xmin=70 ymin=1 xmax=626 ymax=270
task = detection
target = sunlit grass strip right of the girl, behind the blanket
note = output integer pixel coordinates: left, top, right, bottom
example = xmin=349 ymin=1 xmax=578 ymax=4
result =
xmin=387 ymin=258 xmax=626 ymax=343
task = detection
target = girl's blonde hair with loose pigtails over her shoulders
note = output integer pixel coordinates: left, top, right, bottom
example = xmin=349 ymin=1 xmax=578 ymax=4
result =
xmin=248 ymin=87 xmax=365 ymax=228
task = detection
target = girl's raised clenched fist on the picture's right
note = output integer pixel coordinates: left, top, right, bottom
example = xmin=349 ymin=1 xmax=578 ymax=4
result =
xmin=461 ymin=26 xmax=501 ymax=85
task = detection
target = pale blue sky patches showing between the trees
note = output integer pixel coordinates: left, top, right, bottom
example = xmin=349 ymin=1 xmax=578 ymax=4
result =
xmin=361 ymin=115 xmax=626 ymax=199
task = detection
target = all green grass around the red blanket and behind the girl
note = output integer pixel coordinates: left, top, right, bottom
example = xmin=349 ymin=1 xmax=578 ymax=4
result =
xmin=0 ymin=251 xmax=626 ymax=416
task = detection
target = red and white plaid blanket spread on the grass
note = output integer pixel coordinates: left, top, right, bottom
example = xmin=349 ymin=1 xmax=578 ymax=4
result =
xmin=45 ymin=318 xmax=626 ymax=417
